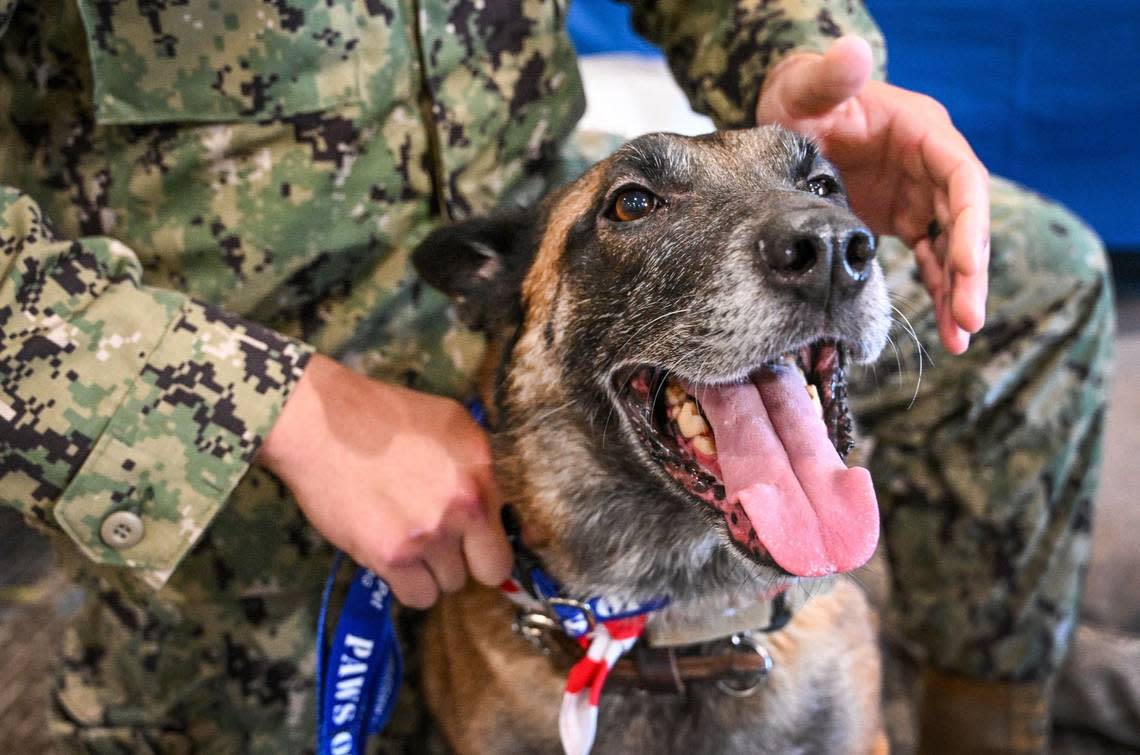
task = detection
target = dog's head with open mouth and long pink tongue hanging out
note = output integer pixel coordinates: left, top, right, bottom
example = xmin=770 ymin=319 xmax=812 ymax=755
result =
xmin=415 ymin=128 xmax=889 ymax=595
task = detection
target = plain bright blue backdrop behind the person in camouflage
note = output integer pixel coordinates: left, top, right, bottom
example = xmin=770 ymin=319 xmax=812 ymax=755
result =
xmin=569 ymin=0 xmax=1140 ymax=250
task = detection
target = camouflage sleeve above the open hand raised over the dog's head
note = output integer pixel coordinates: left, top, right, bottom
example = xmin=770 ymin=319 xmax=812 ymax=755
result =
xmin=624 ymin=0 xmax=887 ymax=128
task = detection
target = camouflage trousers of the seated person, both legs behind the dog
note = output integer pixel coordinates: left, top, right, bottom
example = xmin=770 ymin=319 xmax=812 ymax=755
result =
xmin=52 ymin=175 xmax=1113 ymax=753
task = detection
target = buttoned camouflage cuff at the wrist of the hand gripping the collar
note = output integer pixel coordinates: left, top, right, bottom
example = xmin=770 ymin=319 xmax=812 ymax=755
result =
xmin=54 ymin=300 xmax=312 ymax=588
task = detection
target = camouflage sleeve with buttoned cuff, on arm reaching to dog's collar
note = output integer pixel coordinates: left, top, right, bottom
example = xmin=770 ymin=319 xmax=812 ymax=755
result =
xmin=0 ymin=189 xmax=310 ymax=588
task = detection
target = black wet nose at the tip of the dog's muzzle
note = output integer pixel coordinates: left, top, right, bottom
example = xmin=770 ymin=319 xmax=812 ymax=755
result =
xmin=757 ymin=208 xmax=874 ymax=305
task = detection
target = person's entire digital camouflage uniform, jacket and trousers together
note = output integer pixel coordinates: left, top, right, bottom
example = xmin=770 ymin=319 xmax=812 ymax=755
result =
xmin=0 ymin=0 xmax=1112 ymax=753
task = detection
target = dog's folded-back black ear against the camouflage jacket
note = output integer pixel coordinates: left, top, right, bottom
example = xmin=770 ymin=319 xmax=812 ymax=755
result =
xmin=412 ymin=209 xmax=534 ymax=332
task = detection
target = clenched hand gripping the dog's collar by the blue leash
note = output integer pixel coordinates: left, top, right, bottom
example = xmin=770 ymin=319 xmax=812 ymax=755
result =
xmin=258 ymin=355 xmax=511 ymax=608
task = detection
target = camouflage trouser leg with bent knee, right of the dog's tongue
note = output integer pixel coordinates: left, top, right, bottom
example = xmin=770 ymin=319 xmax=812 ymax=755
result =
xmin=850 ymin=179 xmax=1115 ymax=681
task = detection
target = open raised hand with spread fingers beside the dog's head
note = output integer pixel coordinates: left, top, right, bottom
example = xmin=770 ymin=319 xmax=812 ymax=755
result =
xmin=756 ymin=36 xmax=990 ymax=354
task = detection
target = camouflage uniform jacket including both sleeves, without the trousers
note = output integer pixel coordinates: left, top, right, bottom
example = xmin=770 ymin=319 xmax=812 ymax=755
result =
xmin=0 ymin=0 xmax=882 ymax=587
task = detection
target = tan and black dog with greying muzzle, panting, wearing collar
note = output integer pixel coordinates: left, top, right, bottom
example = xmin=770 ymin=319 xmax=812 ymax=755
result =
xmin=413 ymin=127 xmax=889 ymax=754
